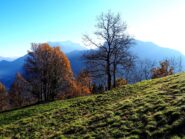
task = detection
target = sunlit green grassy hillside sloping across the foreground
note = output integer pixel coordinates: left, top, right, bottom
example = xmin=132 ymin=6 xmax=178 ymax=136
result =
xmin=0 ymin=73 xmax=185 ymax=139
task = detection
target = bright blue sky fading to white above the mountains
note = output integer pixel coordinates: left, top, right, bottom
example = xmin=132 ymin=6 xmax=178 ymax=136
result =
xmin=0 ymin=0 xmax=185 ymax=57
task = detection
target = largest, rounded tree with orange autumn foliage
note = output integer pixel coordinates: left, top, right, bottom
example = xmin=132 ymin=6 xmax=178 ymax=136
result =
xmin=25 ymin=43 xmax=74 ymax=102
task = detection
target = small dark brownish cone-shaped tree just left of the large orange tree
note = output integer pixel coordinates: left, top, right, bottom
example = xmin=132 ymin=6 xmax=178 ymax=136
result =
xmin=9 ymin=73 xmax=35 ymax=107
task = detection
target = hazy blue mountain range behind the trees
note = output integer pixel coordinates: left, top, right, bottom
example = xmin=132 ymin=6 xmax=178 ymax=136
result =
xmin=0 ymin=40 xmax=185 ymax=88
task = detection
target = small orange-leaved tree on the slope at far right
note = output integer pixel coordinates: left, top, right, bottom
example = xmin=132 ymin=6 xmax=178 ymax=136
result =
xmin=152 ymin=60 xmax=174 ymax=79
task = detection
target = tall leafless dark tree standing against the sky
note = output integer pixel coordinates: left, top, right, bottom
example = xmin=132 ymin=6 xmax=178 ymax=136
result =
xmin=84 ymin=11 xmax=133 ymax=90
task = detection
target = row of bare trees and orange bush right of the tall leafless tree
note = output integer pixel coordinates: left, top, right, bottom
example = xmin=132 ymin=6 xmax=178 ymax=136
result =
xmin=120 ymin=57 xmax=183 ymax=83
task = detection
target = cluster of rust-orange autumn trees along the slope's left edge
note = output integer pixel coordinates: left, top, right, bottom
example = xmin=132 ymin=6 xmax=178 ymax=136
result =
xmin=0 ymin=44 xmax=92 ymax=110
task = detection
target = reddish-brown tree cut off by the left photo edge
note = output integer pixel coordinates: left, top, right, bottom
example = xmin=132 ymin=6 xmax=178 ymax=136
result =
xmin=0 ymin=83 xmax=8 ymax=111
